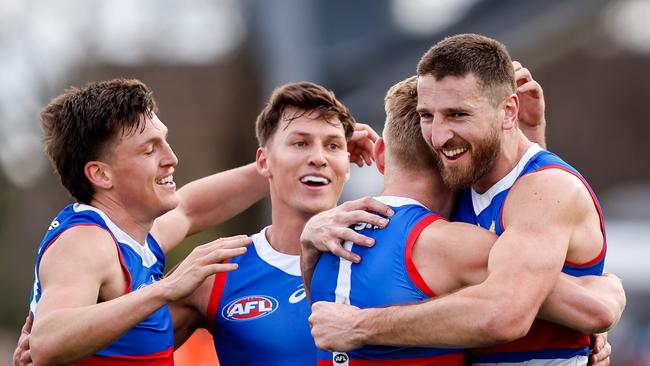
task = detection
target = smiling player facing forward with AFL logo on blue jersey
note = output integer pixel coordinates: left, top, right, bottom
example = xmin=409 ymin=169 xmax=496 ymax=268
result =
xmin=171 ymin=82 xmax=374 ymax=366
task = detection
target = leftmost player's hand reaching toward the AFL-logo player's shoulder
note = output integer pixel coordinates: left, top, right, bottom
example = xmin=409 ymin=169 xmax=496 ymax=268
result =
xmin=159 ymin=235 xmax=252 ymax=302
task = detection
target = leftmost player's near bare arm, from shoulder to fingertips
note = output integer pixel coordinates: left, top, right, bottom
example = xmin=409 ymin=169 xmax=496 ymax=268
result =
xmin=30 ymin=227 xmax=250 ymax=365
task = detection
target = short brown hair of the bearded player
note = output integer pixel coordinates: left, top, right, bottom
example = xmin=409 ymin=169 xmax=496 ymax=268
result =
xmin=417 ymin=34 xmax=516 ymax=103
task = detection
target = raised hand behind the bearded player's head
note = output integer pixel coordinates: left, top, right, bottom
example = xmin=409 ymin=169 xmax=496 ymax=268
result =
xmin=512 ymin=61 xmax=546 ymax=148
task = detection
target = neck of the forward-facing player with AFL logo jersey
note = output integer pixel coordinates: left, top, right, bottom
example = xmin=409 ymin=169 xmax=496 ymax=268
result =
xmin=266 ymin=197 xmax=312 ymax=255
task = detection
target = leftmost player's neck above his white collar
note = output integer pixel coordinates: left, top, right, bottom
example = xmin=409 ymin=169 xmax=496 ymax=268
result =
xmin=90 ymin=196 xmax=155 ymax=245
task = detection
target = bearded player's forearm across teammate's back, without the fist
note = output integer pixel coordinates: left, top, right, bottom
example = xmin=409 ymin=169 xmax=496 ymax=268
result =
xmin=358 ymin=280 xmax=534 ymax=348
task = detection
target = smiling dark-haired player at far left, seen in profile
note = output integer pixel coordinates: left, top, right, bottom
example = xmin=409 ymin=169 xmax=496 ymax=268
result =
xmin=24 ymin=79 xmax=266 ymax=365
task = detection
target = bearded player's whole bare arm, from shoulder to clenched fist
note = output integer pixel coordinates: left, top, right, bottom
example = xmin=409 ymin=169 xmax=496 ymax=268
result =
xmin=310 ymin=171 xmax=584 ymax=351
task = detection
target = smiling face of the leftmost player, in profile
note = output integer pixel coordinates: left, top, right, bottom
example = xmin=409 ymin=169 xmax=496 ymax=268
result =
xmin=108 ymin=115 xmax=179 ymax=219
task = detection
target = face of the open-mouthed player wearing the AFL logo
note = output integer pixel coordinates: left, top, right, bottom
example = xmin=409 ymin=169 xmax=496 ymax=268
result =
xmin=261 ymin=108 xmax=350 ymax=215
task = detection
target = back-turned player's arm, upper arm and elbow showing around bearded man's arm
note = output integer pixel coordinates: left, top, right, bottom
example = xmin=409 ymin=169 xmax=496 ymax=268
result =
xmin=413 ymin=220 xmax=625 ymax=334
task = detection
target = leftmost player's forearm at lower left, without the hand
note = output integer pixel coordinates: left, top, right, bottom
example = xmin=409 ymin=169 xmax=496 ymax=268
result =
xmin=30 ymin=284 xmax=166 ymax=365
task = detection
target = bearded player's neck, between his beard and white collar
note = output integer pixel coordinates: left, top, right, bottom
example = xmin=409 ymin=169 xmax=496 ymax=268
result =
xmin=472 ymin=128 xmax=533 ymax=193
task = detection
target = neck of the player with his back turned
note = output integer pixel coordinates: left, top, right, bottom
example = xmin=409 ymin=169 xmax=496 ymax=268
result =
xmin=382 ymin=164 xmax=456 ymax=218
